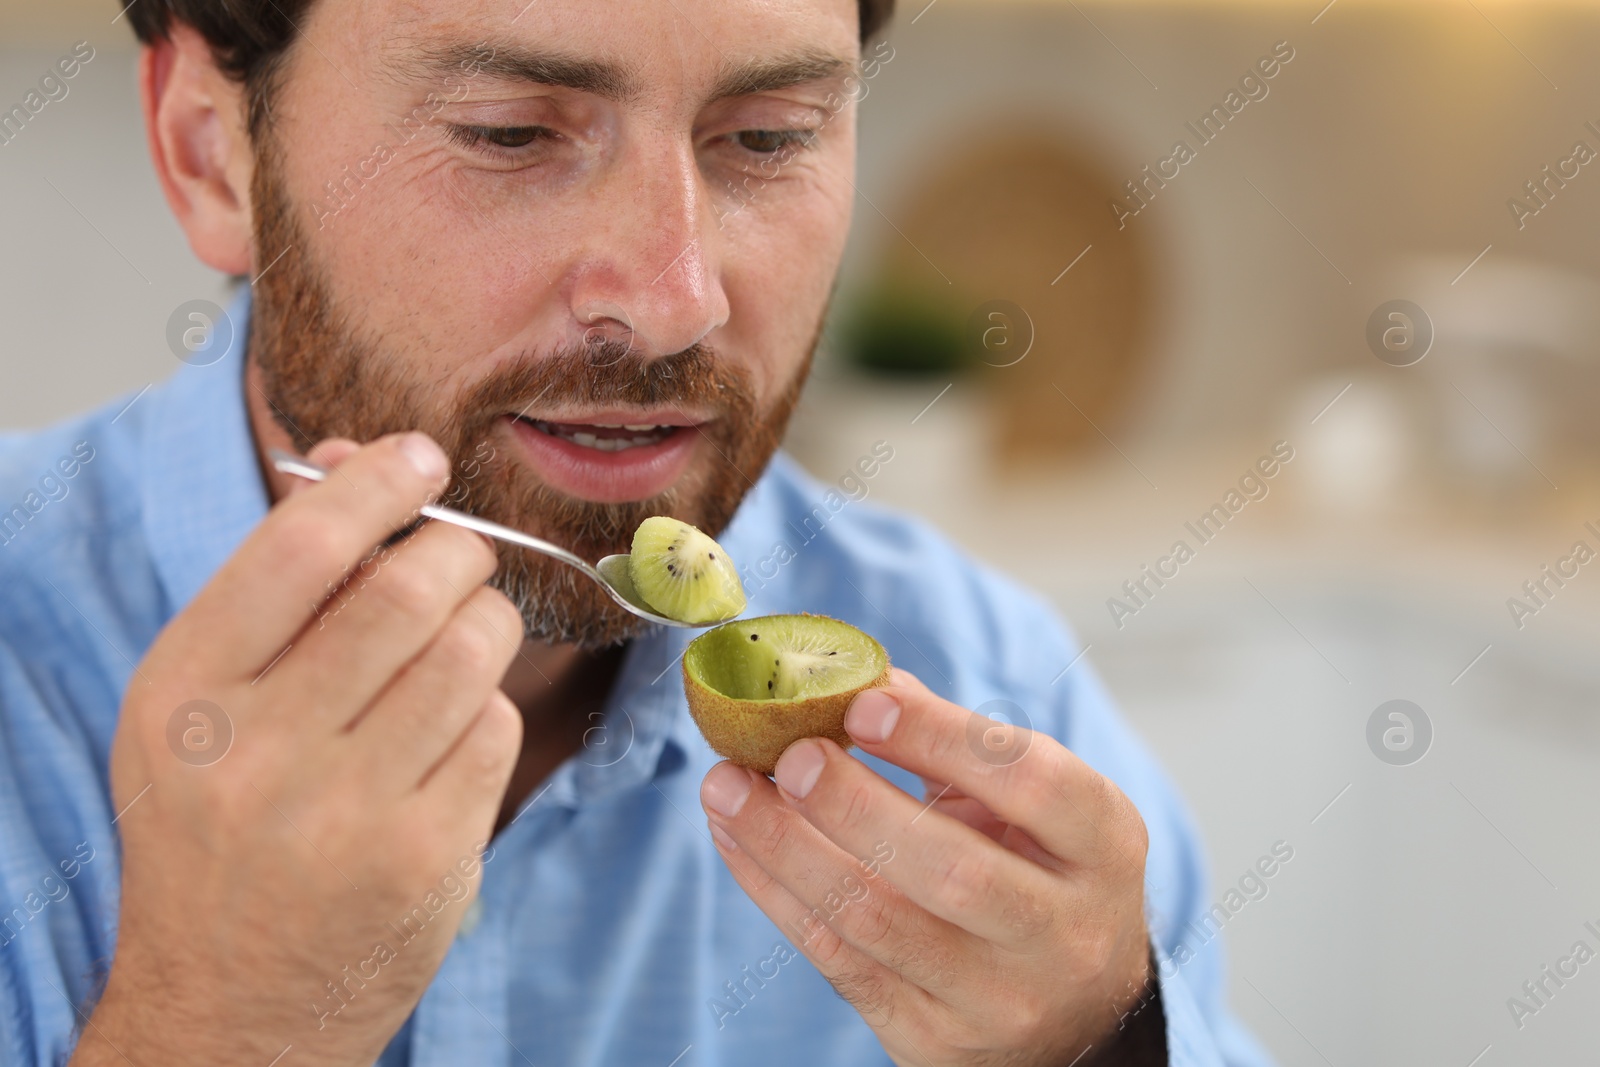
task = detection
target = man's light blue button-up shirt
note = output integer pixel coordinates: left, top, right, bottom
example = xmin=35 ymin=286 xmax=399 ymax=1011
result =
xmin=0 ymin=287 xmax=1267 ymax=1067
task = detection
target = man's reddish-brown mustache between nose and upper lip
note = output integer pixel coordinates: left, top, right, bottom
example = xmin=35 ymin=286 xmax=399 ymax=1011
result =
xmin=461 ymin=339 xmax=755 ymax=422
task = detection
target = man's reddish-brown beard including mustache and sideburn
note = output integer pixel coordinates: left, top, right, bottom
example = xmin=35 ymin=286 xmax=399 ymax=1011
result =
xmin=248 ymin=133 xmax=826 ymax=649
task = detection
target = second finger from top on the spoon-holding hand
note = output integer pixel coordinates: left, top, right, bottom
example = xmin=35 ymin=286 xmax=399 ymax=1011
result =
xmin=266 ymin=523 xmax=504 ymax=729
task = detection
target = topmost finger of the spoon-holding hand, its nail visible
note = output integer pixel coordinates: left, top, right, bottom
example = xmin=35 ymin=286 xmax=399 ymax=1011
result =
xmin=152 ymin=434 xmax=450 ymax=678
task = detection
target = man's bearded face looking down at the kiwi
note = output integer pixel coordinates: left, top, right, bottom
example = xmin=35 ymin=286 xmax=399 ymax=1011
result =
xmin=251 ymin=0 xmax=859 ymax=645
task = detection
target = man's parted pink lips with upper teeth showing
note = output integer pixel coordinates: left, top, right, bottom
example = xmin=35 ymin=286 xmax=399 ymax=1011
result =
xmin=506 ymin=411 xmax=701 ymax=504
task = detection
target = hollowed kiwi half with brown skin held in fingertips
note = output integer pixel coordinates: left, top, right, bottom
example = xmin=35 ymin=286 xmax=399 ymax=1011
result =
xmin=683 ymin=614 xmax=890 ymax=774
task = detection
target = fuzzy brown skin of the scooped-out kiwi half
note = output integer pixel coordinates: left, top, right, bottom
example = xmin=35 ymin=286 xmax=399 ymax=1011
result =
xmin=683 ymin=652 xmax=893 ymax=777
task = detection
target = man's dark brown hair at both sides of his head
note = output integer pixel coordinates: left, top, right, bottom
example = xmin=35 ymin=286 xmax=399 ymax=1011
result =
xmin=123 ymin=0 xmax=894 ymax=133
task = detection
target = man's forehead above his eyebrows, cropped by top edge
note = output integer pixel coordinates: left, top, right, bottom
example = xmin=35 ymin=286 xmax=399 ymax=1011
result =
xmin=312 ymin=0 xmax=859 ymax=88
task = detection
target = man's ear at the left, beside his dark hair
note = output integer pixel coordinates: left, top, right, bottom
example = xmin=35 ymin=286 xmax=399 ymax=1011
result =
xmin=139 ymin=22 xmax=253 ymax=275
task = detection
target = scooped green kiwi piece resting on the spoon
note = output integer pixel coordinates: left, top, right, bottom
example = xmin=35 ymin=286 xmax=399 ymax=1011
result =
xmin=629 ymin=515 xmax=746 ymax=622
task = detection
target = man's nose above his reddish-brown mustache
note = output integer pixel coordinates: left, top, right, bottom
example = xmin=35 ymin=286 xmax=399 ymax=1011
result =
xmin=571 ymin=135 xmax=728 ymax=355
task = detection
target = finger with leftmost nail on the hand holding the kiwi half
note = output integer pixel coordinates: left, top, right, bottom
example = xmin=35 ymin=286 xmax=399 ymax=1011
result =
xmin=702 ymin=758 xmax=986 ymax=995
